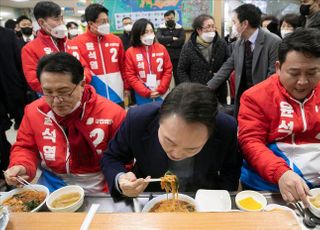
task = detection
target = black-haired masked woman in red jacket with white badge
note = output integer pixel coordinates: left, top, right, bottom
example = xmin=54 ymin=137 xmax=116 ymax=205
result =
xmin=125 ymin=18 xmax=172 ymax=105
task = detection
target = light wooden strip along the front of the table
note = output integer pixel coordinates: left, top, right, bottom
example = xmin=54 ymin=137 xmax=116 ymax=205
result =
xmin=7 ymin=211 xmax=301 ymax=230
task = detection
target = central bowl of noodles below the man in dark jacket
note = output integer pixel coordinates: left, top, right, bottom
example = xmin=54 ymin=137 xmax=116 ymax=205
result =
xmin=142 ymin=193 xmax=197 ymax=212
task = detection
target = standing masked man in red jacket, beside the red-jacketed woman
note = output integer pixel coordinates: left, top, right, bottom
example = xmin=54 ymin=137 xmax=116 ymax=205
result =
xmin=67 ymin=4 xmax=129 ymax=104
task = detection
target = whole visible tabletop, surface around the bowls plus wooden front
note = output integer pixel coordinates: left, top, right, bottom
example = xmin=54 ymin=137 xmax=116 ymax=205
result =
xmin=0 ymin=192 xmax=301 ymax=230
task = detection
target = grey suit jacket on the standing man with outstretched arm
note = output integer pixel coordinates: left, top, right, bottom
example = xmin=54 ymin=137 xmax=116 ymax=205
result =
xmin=208 ymin=28 xmax=281 ymax=112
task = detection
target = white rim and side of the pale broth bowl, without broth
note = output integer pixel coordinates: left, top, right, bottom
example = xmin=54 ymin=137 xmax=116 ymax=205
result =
xmin=46 ymin=185 xmax=84 ymax=212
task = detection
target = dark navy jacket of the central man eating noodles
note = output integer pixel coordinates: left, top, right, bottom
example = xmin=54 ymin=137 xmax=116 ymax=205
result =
xmin=102 ymin=102 xmax=242 ymax=196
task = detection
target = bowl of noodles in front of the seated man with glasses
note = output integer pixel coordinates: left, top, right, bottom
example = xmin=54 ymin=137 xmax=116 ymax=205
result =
xmin=0 ymin=184 xmax=49 ymax=212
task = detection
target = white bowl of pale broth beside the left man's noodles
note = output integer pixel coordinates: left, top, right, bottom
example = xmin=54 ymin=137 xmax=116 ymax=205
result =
xmin=46 ymin=185 xmax=84 ymax=212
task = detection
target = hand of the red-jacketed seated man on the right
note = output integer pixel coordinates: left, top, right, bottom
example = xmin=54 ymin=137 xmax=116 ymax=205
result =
xmin=278 ymin=170 xmax=309 ymax=207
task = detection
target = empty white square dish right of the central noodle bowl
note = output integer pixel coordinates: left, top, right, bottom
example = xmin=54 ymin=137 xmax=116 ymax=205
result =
xmin=195 ymin=189 xmax=231 ymax=212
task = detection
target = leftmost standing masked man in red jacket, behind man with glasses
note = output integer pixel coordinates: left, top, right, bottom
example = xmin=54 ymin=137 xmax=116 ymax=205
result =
xmin=21 ymin=1 xmax=67 ymax=93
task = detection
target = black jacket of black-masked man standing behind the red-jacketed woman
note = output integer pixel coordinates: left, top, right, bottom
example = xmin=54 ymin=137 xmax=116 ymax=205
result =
xmin=156 ymin=24 xmax=186 ymax=60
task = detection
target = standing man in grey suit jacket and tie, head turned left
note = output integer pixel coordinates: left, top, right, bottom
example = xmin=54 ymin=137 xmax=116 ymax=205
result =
xmin=208 ymin=4 xmax=281 ymax=116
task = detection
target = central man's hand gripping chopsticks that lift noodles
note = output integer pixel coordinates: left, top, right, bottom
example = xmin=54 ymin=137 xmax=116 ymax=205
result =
xmin=119 ymin=172 xmax=151 ymax=197
